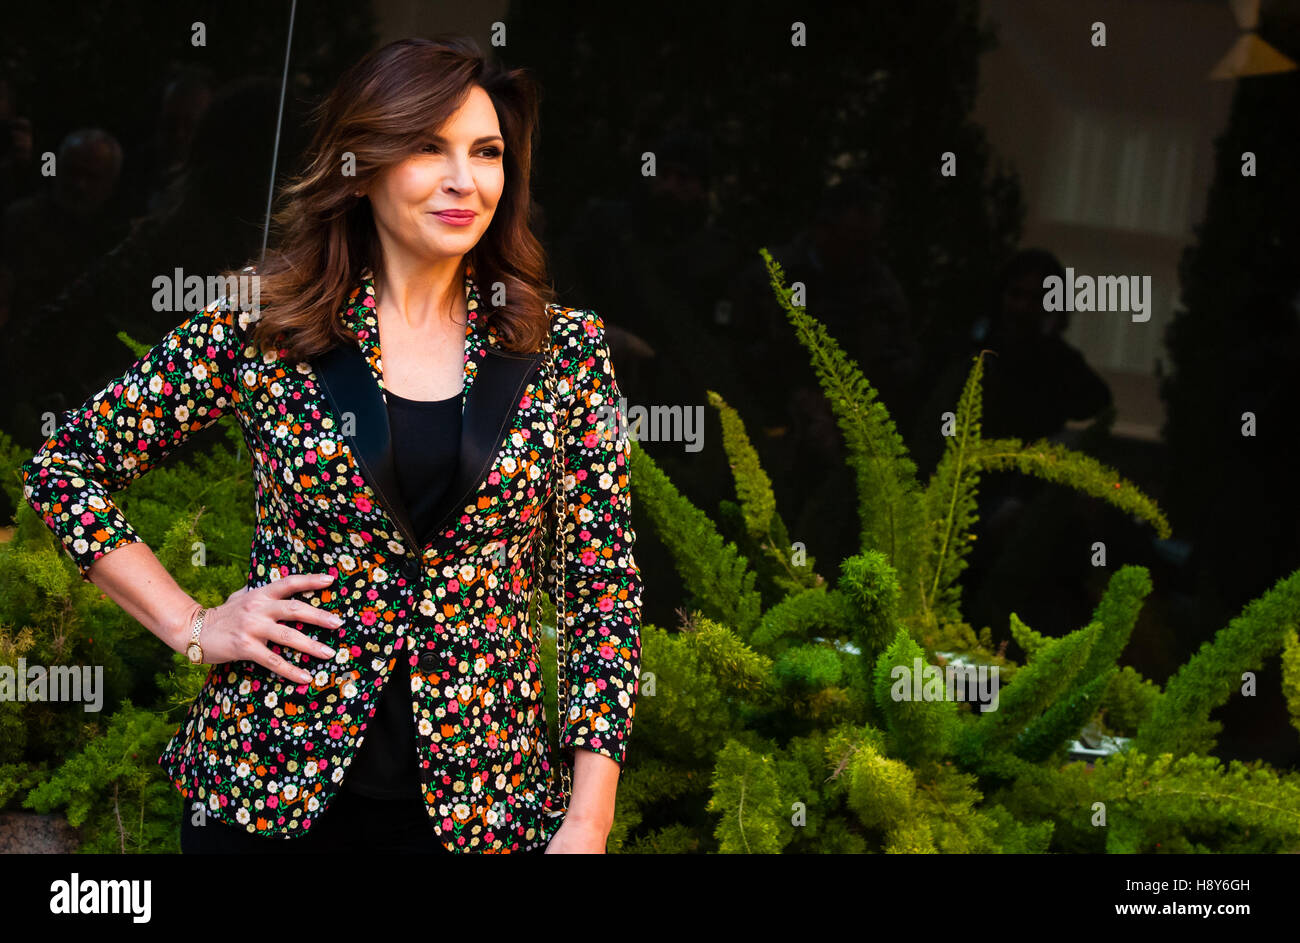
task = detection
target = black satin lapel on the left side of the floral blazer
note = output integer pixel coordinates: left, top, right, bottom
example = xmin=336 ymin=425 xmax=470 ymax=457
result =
xmin=312 ymin=343 xmax=418 ymax=554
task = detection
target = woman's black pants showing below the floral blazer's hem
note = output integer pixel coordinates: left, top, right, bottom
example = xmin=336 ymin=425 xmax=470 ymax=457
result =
xmin=181 ymin=790 xmax=546 ymax=855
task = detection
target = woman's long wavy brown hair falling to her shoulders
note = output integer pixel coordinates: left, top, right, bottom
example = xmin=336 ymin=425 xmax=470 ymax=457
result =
xmin=222 ymin=34 xmax=555 ymax=362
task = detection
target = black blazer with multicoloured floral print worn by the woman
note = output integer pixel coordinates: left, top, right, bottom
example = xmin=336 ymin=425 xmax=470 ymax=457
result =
xmin=22 ymin=267 xmax=641 ymax=852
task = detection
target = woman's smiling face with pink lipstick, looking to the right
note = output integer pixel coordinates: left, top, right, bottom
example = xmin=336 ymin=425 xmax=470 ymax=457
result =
xmin=363 ymin=86 xmax=506 ymax=261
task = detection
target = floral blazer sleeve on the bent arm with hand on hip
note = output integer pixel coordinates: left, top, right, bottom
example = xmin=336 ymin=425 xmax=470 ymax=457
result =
xmin=21 ymin=299 xmax=242 ymax=580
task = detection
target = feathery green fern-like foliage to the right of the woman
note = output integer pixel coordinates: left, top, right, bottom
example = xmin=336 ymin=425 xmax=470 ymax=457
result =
xmin=608 ymin=245 xmax=1300 ymax=853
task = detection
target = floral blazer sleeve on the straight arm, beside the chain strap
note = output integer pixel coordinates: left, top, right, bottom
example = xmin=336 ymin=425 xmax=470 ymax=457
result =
xmin=559 ymin=311 xmax=641 ymax=765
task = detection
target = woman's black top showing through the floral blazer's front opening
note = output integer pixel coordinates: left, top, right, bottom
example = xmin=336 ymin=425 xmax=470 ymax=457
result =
xmin=343 ymin=392 xmax=462 ymax=800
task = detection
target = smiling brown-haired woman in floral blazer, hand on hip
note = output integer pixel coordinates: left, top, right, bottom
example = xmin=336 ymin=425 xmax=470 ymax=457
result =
xmin=22 ymin=40 xmax=641 ymax=852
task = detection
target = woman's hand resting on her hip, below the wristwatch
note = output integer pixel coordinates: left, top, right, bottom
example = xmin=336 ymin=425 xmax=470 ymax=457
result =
xmin=189 ymin=574 xmax=343 ymax=684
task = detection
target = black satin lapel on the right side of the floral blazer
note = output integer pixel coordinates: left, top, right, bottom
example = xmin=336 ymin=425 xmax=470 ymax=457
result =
xmin=425 ymin=347 xmax=545 ymax=546
